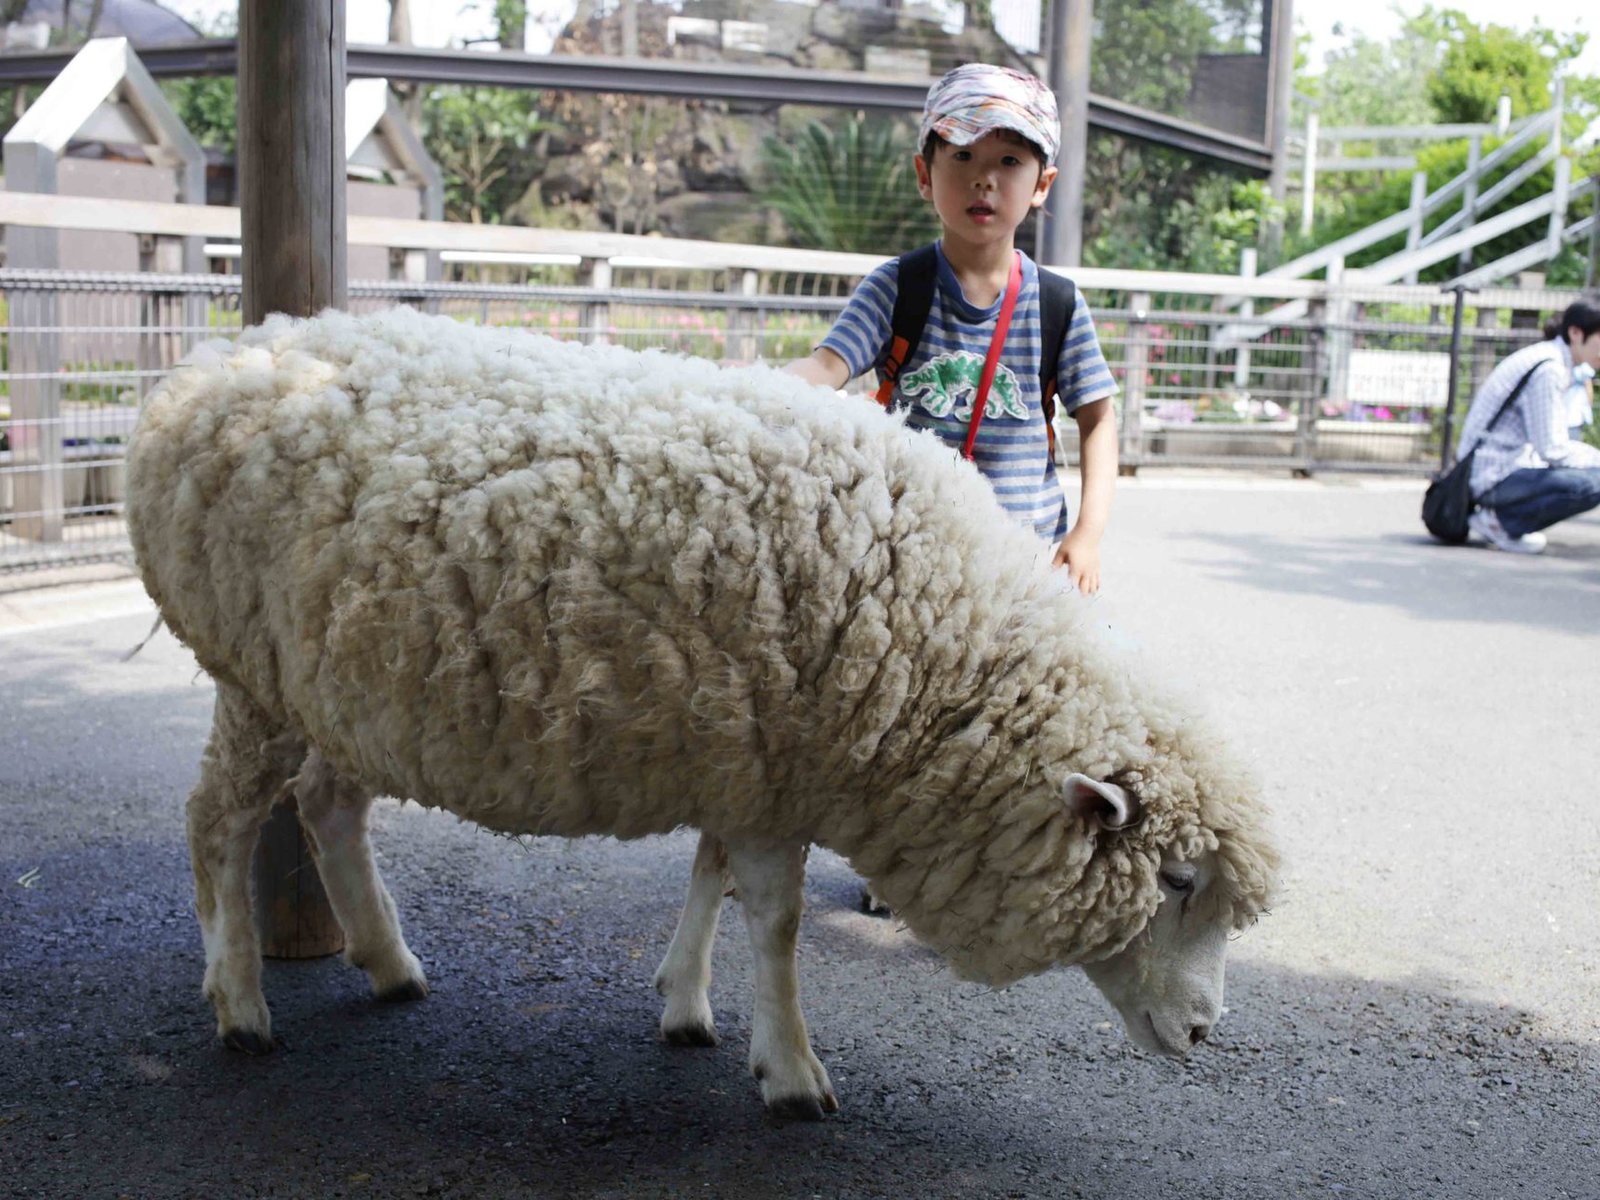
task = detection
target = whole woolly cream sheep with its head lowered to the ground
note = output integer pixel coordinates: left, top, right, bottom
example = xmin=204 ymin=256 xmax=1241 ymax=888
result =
xmin=126 ymin=309 xmax=1277 ymax=1117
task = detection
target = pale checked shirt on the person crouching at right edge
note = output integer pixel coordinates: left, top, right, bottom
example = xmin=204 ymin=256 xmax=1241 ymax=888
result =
xmin=1456 ymin=338 xmax=1600 ymax=496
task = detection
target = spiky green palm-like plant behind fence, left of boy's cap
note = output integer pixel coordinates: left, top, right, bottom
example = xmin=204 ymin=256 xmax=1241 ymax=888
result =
xmin=762 ymin=114 xmax=939 ymax=253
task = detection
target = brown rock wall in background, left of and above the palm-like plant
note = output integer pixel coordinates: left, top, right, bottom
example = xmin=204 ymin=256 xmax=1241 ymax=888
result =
xmin=512 ymin=0 xmax=1038 ymax=243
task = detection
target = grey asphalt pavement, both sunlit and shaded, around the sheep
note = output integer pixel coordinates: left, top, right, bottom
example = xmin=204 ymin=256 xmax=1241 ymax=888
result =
xmin=0 ymin=474 xmax=1600 ymax=1200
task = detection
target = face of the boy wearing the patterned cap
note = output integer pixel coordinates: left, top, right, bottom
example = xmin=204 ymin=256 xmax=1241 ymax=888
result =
xmin=917 ymin=130 xmax=1056 ymax=243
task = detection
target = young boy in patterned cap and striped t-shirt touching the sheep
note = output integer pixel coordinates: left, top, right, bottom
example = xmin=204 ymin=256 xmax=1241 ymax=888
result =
xmin=787 ymin=62 xmax=1117 ymax=594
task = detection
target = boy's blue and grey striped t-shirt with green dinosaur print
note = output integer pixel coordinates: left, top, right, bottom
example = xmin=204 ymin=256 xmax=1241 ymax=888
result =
xmin=822 ymin=246 xmax=1117 ymax=542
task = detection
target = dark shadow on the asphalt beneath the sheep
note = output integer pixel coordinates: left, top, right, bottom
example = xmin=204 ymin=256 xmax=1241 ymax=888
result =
xmin=0 ymin=825 xmax=1600 ymax=1198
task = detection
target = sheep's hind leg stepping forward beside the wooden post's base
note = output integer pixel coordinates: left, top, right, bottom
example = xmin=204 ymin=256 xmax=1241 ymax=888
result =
xmin=294 ymin=749 xmax=427 ymax=1000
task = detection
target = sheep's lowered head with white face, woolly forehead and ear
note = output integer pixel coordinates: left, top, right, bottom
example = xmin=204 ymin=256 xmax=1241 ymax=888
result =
xmin=1067 ymin=774 xmax=1277 ymax=1058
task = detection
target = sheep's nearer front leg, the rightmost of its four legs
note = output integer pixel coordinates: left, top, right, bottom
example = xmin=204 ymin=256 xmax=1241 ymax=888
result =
xmin=728 ymin=842 xmax=838 ymax=1120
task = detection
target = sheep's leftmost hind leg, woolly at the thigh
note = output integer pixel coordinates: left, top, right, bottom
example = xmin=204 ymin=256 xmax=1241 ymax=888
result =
xmin=189 ymin=680 xmax=304 ymax=1054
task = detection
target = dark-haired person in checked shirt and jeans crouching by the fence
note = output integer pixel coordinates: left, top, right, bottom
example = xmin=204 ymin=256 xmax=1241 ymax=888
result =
xmin=1458 ymin=294 xmax=1600 ymax=554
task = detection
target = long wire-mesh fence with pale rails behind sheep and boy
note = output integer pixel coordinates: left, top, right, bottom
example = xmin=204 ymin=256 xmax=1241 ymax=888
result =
xmin=0 ymin=269 xmax=1570 ymax=582
